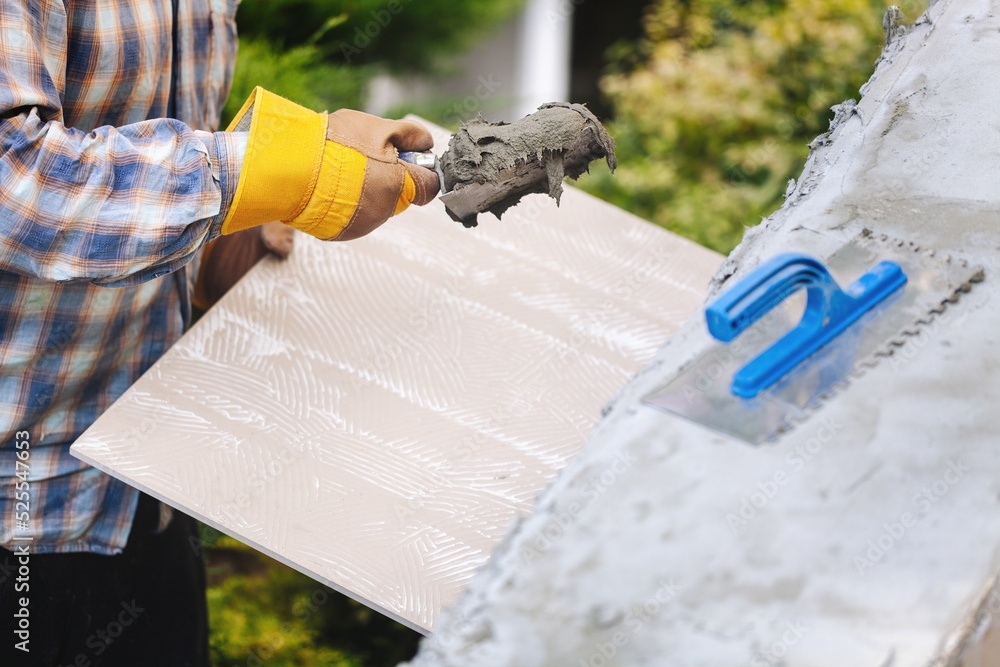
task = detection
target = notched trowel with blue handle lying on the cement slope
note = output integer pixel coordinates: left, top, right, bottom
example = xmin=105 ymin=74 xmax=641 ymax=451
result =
xmin=644 ymin=233 xmax=983 ymax=444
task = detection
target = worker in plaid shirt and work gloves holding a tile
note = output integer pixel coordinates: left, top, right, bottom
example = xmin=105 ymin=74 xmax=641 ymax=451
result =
xmin=0 ymin=0 xmax=438 ymax=667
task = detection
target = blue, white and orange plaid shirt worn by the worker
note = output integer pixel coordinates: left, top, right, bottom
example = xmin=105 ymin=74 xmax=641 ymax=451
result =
xmin=0 ymin=0 xmax=246 ymax=554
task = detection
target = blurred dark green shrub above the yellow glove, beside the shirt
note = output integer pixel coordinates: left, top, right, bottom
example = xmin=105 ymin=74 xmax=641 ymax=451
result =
xmin=222 ymin=0 xmax=525 ymax=122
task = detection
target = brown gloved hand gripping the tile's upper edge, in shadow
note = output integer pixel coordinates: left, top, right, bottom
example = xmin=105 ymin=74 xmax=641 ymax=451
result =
xmin=194 ymin=222 xmax=295 ymax=310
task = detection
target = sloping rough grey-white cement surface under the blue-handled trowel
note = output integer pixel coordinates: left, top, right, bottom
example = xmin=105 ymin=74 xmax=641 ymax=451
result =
xmin=402 ymin=0 xmax=1000 ymax=667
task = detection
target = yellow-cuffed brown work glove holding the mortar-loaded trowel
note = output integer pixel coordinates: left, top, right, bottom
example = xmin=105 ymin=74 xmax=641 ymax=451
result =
xmin=222 ymin=87 xmax=439 ymax=241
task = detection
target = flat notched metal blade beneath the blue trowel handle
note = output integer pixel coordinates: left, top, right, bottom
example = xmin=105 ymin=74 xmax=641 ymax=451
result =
xmin=643 ymin=236 xmax=982 ymax=444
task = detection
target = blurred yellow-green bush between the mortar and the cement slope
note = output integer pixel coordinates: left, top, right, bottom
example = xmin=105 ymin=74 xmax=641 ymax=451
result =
xmin=581 ymin=0 xmax=912 ymax=252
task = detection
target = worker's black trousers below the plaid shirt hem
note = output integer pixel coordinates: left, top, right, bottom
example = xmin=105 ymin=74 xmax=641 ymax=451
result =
xmin=0 ymin=494 xmax=209 ymax=667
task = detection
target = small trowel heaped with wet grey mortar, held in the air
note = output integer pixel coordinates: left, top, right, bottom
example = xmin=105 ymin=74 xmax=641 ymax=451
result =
xmin=400 ymin=102 xmax=617 ymax=227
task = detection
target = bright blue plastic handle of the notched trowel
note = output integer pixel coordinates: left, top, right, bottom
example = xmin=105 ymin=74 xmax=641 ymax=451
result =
xmin=705 ymin=253 xmax=906 ymax=398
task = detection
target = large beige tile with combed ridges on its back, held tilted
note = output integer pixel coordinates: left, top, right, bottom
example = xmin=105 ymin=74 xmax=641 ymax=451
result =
xmin=73 ymin=118 xmax=722 ymax=631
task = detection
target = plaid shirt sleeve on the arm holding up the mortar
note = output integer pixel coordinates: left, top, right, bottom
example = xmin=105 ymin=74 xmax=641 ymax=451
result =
xmin=0 ymin=0 xmax=246 ymax=286
